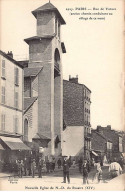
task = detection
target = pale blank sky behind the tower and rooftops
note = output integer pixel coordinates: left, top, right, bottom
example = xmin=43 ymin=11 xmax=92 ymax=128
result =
xmin=0 ymin=0 xmax=124 ymax=130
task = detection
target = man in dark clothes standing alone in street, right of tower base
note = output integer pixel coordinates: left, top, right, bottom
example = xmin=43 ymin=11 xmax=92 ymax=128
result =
xmin=63 ymin=156 xmax=70 ymax=183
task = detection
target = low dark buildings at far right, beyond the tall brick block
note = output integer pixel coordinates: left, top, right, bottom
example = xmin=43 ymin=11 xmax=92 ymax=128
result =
xmin=92 ymin=125 xmax=124 ymax=162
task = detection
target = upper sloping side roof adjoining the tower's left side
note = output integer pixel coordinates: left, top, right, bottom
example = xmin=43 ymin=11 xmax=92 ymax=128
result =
xmin=24 ymin=67 xmax=43 ymax=77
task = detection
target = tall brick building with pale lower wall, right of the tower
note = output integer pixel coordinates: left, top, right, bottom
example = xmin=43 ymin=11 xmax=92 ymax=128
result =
xmin=62 ymin=76 xmax=91 ymax=159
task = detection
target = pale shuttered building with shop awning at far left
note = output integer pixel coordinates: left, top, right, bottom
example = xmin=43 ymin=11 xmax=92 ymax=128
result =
xmin=0 ymin=51 xmax=29 ymax=169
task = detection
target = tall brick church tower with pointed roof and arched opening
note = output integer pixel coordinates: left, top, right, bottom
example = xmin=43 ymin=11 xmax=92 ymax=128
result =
xmin=25 ymin=3 xmax=66 ymax=155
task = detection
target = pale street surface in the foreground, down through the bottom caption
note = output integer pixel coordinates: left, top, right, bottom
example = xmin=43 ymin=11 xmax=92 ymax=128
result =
xmin=0 ymin=167 xmax=123 ymax=191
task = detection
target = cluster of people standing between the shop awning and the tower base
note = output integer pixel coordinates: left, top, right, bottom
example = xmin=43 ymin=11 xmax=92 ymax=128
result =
xmin=16 ymin=157 xmax=62 ymax=178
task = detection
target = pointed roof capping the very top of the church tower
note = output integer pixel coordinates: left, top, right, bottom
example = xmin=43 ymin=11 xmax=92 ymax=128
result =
xmin=32 ymin=2 xmax=66 ymax=24
